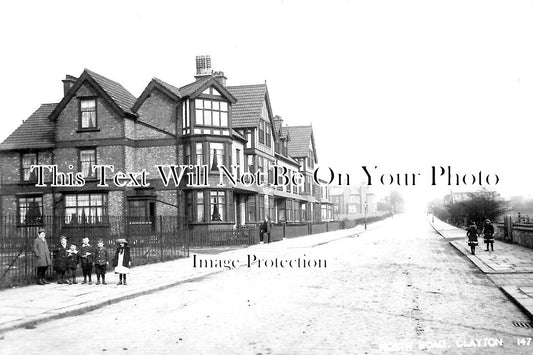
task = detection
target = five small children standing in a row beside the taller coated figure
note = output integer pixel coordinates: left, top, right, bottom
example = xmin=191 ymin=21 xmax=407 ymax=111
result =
xmin=54 ymin=236 xmax=131 ymax=285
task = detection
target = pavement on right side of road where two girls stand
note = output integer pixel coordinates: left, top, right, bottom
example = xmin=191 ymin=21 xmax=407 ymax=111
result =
xmin=428 ymin=217 xmax=533 ymax=321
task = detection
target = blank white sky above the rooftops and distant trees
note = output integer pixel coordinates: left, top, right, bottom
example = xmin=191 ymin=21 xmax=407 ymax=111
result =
xmin=0 ymin=0 xmax=533 ymax=210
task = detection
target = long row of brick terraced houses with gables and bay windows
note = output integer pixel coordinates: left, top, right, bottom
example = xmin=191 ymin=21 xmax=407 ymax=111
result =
xmin=0 ymin=56 xmax=331 ymax=235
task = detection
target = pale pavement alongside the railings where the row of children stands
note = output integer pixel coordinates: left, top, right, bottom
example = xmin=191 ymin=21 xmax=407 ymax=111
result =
xmin=0 ymin=220 xmax=386 ymax=339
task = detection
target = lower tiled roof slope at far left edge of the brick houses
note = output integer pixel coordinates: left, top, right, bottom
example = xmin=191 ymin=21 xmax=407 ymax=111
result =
xmin=0 ymin=104 xmax=57 ymax=150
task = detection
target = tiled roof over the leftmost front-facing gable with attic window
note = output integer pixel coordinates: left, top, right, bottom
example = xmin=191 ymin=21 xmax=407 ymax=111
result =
xmin=50 ymin=69 xmax=136 ymax=120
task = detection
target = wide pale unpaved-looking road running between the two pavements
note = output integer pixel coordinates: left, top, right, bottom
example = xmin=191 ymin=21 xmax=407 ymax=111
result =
xmin=0 ymin=216 xmax=533 ymax=354
